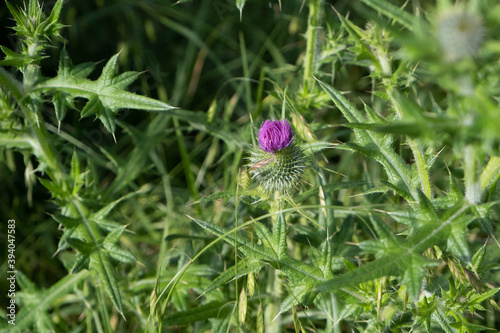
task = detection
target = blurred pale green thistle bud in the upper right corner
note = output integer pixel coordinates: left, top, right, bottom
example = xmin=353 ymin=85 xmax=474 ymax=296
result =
xmin=437 ymin=7 xmax=485 ymax=62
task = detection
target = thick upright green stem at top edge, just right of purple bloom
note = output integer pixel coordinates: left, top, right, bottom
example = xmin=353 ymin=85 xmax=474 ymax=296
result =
xmin=303 ymin=0 xmax=321 ymax=94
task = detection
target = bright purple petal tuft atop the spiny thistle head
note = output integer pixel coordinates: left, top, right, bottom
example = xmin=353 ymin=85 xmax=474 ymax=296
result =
xmin=259 ymin=119 xmax=293 ymax=153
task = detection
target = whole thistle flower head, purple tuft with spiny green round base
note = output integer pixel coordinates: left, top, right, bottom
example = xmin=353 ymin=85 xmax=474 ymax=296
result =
xmin=248 ymin=119 xmax=305 ymax=193
